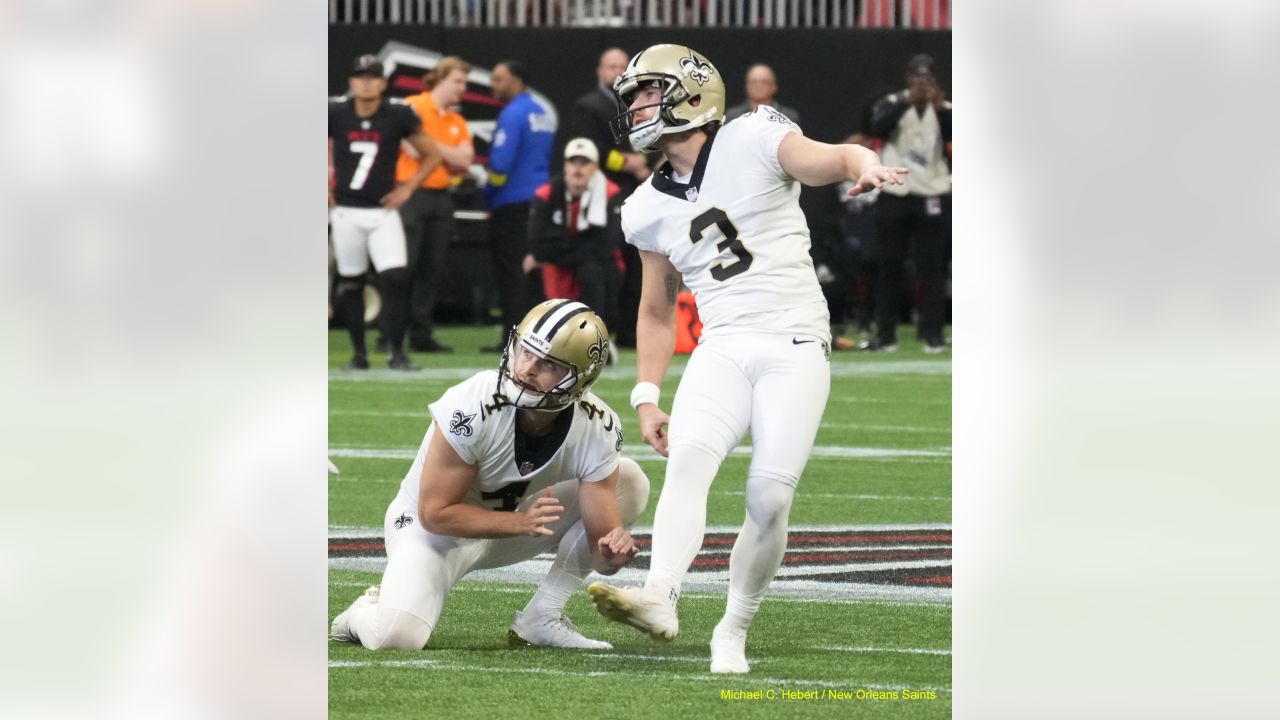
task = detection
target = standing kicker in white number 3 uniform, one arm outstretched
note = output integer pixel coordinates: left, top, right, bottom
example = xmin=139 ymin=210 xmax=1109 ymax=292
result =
xmin=588 ymin=45 xmax=906 ymax=673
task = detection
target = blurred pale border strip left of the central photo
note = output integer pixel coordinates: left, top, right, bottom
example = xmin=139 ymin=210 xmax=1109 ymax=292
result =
xmin=0 ymin=0 xmax=328 ymax=719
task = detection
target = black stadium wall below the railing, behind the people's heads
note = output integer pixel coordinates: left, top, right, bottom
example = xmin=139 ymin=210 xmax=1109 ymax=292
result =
xmin=329 ymin=26 xmax=951 ymax=142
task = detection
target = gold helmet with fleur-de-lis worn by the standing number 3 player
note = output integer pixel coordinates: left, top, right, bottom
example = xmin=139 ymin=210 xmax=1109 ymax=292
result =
xmin=611 ymin=45 xmax=724 ymax=150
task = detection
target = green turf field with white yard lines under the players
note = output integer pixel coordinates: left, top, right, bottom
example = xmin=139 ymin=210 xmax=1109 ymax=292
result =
xmin=330 ymin=327 xmax=951 ymax=719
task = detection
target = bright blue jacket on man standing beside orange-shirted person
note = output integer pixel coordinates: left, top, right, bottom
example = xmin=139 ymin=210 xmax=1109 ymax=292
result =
xmin=484 ymin=91 xmax=556 ymax=210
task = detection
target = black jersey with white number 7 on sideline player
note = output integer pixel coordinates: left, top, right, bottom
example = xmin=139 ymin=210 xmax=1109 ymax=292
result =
xmin=329 ymin=97 xmax=422 ymax=208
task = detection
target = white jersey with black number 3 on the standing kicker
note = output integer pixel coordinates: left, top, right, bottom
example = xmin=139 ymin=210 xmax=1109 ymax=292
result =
xmin=622 ymin=105 xmax=831 ymax=341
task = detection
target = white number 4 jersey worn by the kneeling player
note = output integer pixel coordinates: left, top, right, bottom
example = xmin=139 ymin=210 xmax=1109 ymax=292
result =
xmin=399 ymin=370 xmax=622 ymax=510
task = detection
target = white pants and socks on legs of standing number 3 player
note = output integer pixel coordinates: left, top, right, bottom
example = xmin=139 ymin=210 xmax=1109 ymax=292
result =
xmin=645 ymin=333 xmax=831 ymax=626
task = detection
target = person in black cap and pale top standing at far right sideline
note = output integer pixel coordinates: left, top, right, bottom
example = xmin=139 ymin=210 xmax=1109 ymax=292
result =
xmin=864 ymin=55 xmax=951 ymax=352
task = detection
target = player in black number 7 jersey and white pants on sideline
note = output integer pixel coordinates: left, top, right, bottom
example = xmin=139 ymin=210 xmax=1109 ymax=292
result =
xmin=329 ymin=55 xmax=440 ymax=370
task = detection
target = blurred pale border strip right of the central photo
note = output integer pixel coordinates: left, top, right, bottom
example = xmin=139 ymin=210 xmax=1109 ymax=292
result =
xmin=954 ymin=0 xmax=1280 ymax=719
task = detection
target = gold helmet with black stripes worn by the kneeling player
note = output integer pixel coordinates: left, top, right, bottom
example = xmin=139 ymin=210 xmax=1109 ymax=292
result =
xmin=498 ymin=300 xmax=609 ymax=411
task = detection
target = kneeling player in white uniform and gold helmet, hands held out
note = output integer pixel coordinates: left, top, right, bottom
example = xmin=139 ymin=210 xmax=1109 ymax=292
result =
xmin=332 ymin=300 xmax=649 ymax=650
